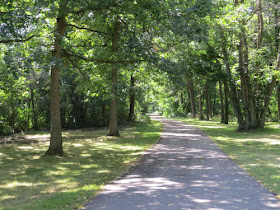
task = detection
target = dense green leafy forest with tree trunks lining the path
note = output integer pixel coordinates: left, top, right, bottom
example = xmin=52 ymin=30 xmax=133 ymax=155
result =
xmin=0 ymin=0 xmax=280 ymax=155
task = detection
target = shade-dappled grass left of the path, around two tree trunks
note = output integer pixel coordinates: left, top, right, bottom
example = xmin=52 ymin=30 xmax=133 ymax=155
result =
xmin=0 ymin=122 xmax=161 ymax=209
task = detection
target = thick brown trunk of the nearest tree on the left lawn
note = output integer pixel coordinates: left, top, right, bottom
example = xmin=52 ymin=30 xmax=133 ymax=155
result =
xmin=46 ymin=5 xmax=66 ymax=156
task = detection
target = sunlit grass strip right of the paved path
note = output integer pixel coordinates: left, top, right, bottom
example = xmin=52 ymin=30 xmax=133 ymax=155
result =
xmin=176 ymin=119 xmax=280 ymax=198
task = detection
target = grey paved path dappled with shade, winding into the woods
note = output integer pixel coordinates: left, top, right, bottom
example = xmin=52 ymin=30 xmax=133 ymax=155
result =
xmin=86 ymin=116 xmax=280 ymax=210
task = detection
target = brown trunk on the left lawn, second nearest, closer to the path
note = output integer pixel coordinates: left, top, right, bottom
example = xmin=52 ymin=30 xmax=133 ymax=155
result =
xmin=108 ymin=21 xmax=120 ymax=136
